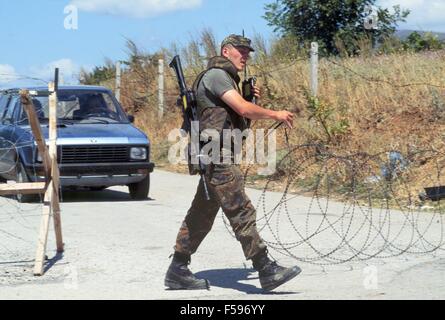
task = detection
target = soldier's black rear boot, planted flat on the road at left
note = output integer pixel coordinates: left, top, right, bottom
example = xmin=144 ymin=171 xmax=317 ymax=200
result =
xmin=164 ymin=252 xmax=210 ymax=290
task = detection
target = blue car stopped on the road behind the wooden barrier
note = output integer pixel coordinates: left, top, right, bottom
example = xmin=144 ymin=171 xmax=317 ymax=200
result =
xmin=0 ymin=86 xmax=154 ymax=202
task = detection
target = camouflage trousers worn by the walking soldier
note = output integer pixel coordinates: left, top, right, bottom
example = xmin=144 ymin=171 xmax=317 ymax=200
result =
xmin=175 ymin=164 xmax=266 ymax=260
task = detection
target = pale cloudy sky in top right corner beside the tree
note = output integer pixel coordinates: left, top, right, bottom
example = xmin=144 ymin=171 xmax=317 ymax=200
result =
xmin=378 ymin=0 xmax=445 ymax=32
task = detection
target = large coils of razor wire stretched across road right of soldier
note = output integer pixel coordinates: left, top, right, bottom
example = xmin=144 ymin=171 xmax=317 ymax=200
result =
xmin=223 ymin=145 xmax=445 ymax=266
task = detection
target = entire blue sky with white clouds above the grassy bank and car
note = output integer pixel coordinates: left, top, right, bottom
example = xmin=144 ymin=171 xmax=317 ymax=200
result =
xmin=0 ymin=0 xmax=445 ymax=87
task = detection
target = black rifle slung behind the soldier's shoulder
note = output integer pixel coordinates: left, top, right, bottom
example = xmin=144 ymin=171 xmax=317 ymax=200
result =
xmin=169 ymin=56 xmax=210 ymax=200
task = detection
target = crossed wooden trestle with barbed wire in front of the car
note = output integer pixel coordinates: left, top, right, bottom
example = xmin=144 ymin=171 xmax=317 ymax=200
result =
xmin=0 ymin=88 xmax=64 ymax=276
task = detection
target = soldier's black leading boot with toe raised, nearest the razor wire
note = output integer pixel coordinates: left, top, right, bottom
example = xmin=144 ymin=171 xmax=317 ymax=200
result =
xmin=252 ymin=251 xmax=301 ymax=291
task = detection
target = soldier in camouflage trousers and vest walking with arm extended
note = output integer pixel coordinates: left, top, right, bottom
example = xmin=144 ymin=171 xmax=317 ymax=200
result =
xmin=165 ymin=35 xmax=301 ymax=290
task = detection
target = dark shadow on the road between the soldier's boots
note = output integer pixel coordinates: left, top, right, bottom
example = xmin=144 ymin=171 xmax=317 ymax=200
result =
xmin=195 ymin=269 xmax=299 ymax=295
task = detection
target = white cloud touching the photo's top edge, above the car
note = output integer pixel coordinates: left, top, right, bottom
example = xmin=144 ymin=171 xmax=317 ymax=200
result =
xmin=70 ymin=0 xmax=202 ymax=18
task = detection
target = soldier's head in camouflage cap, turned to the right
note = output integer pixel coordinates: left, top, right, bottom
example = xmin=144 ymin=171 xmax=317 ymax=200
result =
xmin=221 ymin=34 xmax=255 ymax=71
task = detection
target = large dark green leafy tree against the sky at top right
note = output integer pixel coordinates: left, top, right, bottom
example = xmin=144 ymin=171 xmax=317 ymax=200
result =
xmin=264 ymin=0 xmax=409 ymax=54
